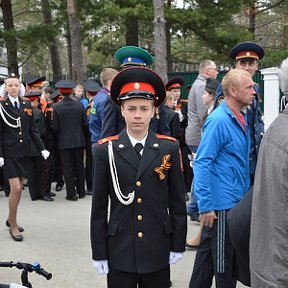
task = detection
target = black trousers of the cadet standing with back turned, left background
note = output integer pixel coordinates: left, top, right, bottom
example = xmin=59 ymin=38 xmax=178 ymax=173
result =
xmin=60 ymin=147 xmax=85 ymax=198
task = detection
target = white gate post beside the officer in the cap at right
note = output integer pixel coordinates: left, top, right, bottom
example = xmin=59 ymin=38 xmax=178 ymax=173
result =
xmin=260 ymin=67 xmax=280 ymax=131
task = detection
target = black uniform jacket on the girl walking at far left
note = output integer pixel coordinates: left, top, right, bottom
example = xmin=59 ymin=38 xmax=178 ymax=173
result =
xmin=0 ymin=97 xmax=45 ymax=158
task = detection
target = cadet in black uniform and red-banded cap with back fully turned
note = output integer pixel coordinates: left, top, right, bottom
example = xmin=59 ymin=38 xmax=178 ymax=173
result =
xmin=51 ymin=80 xmax=88 ymax=201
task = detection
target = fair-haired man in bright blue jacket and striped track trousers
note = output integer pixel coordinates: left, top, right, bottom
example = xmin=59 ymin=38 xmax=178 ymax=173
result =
xmin=189 ymin=69 xmax=255 ymax=288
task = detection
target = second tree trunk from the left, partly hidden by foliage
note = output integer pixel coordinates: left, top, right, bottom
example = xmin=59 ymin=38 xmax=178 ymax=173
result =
xmin=41 ymin=0 xmax=62 ymax=82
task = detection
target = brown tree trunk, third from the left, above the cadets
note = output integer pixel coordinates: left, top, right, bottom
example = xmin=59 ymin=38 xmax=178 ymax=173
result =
xmin=67 ymin=0 xmax=83 ymax=83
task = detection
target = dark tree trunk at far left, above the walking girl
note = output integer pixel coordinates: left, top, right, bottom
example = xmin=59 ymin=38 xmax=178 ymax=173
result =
xmin=0 ymin=0 xmax=19 ymax=76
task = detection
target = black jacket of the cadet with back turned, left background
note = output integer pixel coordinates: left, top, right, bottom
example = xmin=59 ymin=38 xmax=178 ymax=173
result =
xmin=51 ymin=96 xmax=88 ymax=150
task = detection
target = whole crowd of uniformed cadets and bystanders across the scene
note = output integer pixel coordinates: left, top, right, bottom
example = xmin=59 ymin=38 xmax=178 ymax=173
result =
xmin=0 ymin=42 xmax=288 ymax=288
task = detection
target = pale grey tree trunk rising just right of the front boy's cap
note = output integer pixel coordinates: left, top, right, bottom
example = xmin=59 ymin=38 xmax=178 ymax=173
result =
xmin=153 ymin=0 xmax=167 ymax=82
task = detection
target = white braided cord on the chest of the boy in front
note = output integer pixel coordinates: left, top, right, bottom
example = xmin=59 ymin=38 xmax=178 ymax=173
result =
xmin=108 ymin=140 xmax=135 ymax=206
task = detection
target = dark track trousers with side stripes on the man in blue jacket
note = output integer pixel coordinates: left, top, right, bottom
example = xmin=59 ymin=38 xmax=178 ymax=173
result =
xmin=189 ymin=210 xmax=237 ymax=288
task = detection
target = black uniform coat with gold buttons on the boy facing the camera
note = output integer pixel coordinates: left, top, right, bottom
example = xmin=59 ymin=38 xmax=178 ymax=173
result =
xmin=91 ymin=130 xmax=187 ymax=273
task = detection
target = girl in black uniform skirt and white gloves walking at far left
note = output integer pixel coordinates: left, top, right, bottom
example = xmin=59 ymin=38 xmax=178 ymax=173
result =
xmin=0 ymin=77 xmax=50 ymax=241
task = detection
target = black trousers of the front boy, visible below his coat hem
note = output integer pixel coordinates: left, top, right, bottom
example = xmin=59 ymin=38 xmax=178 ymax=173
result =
xmin=107 ymin=266 xmax=170 ymax=288
